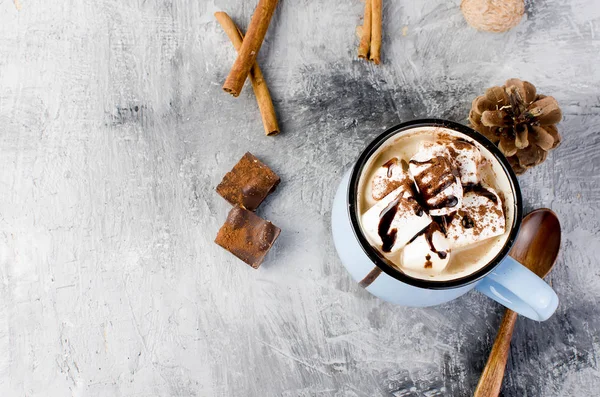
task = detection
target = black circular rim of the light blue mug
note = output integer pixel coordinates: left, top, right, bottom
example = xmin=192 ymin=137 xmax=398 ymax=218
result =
xmin=347 ymin=119 xmax=523 ymax=290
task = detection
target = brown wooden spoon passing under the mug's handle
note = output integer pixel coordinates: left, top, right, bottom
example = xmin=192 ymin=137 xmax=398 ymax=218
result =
xmin=474 ymin=208 xmax=560 ymax=397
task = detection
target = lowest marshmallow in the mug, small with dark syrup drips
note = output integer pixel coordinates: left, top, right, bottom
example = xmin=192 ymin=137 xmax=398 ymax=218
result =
xmin=401 ymin=222 xmax=450 ymax=275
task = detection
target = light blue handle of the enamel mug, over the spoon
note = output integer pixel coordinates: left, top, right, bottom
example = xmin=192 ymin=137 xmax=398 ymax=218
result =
xmin=475 ymin=256 xmax=558 ymax=321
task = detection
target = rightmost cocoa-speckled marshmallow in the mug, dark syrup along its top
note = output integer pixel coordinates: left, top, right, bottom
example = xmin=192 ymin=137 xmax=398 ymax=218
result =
xmin=447 ymin=185 xmax=506 ymax=248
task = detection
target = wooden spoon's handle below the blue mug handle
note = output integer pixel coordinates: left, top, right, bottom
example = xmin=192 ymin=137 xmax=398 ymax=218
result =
xmin=473 ymin=309 xmax=517 ymax=397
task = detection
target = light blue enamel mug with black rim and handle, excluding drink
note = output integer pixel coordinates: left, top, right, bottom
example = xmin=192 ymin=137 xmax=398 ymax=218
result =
xmin=331 ymin=119 xmax=558 ymax=321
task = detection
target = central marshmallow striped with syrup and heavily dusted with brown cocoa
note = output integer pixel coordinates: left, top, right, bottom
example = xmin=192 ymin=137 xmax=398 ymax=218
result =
xmin=409 ymin=145 xmax=463 ymax=216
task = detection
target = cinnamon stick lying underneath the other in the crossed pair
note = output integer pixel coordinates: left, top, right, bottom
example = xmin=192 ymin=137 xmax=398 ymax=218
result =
xmin=215 ymin=11 xmax=279 ymax=136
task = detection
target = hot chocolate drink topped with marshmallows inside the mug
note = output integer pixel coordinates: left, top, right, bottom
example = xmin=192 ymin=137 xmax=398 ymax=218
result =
xmin=358 ymin=127 xmax=515 ymax=281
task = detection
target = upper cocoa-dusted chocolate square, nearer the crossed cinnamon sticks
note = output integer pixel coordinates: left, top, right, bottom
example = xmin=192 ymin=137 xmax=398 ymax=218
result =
xmin=217 ymin=152 xmax=280 ymax=211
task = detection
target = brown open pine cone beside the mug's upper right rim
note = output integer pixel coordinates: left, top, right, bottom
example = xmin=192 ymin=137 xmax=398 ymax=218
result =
xmin=469 ymin=79 xmax=562 ymax=175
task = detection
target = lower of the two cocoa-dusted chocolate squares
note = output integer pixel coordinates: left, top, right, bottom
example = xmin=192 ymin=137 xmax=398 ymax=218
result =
xmin=215 ymin=207 xmax=281 ymax=269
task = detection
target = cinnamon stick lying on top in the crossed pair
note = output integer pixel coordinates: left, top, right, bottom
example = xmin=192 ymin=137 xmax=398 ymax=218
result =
xmin=223 ymin=0 xmax=277 ymax=97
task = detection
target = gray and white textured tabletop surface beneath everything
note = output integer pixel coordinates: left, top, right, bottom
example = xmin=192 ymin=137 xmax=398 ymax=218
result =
xmin=0 ymin=0 xmax=600 ymax=397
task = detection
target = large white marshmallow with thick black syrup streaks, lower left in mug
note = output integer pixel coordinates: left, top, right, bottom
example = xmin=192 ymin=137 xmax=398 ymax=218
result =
xmin=361 ymin=185 xmax=431 ymax=254
